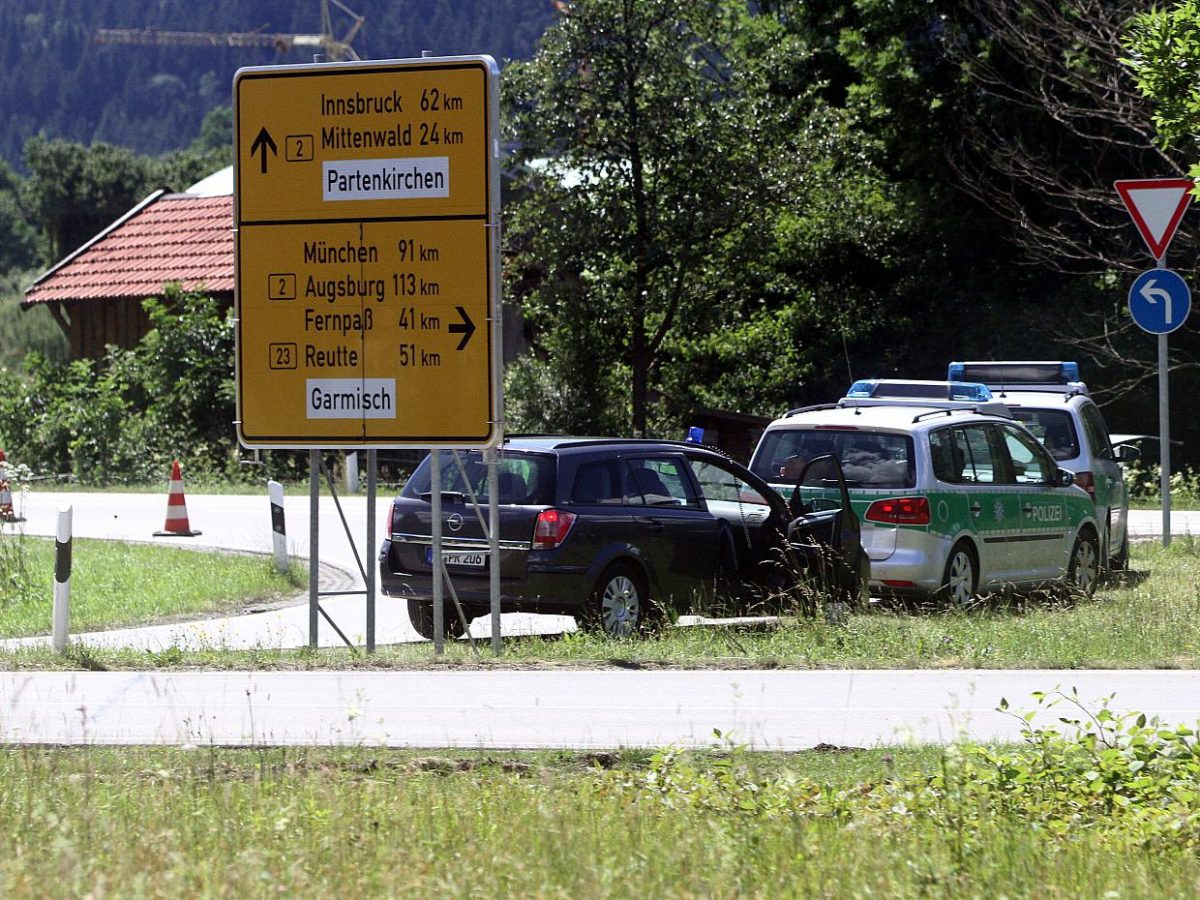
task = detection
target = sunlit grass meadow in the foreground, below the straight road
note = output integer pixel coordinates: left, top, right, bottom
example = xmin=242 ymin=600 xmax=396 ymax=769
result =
xmin=0 ymin=722 xmax=1200 ymax=900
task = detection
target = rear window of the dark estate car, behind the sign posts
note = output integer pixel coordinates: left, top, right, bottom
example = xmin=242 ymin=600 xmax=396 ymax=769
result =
xmin=403 ymin=450 xmax=554 ymax=506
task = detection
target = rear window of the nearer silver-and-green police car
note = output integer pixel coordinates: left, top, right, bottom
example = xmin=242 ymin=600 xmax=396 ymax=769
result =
xmin=750 ymin=428 xmax=917 ymax=488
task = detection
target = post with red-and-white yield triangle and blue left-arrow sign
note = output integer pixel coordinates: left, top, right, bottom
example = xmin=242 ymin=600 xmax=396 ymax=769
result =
xmin=1114 ymin=178 xmax=1195 ymax=547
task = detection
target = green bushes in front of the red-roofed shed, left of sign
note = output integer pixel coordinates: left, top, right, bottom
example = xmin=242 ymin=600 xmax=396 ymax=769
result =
xmin=0 ymin=289 xmax=302 ymax=485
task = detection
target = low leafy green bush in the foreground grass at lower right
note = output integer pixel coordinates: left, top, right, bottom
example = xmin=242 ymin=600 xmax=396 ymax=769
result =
xmin=609 ymin=690 xmax=1200 ymax=864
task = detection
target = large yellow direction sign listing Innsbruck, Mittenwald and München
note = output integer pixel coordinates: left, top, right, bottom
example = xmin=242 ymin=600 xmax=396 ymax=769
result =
xmin=234 ymin=56 xmax=500 ymax=448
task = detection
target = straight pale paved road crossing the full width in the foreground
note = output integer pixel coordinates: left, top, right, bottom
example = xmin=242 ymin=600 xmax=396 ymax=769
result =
xmin=7 ymin=670 xmax=1200 ymax=750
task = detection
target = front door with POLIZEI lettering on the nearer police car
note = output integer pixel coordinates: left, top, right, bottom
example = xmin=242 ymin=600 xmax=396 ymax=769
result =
xmin=1001 ymin=425 xmax=1070 ymax=581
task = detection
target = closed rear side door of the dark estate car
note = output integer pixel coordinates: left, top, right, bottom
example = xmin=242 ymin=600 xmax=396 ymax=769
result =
xmin=622 ymin=454 xmax=720 ymax=605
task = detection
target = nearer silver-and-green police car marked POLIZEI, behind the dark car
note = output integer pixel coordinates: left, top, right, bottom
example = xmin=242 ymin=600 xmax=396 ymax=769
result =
xmin=750 ymin=382 xmax=1100 ymax=606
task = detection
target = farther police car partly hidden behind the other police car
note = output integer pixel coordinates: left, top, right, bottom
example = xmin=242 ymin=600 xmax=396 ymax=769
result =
xmin=948 ymin=361 xmax=1139 ymax=569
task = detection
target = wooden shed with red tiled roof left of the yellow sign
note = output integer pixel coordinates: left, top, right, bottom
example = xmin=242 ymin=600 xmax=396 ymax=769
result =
xmin=22 ymin=191 xmax=234 ymax=359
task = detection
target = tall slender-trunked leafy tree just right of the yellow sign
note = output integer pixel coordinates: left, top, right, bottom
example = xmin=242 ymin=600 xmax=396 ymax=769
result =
xmin=506 ymin=0 xmax=758 ymax=433
